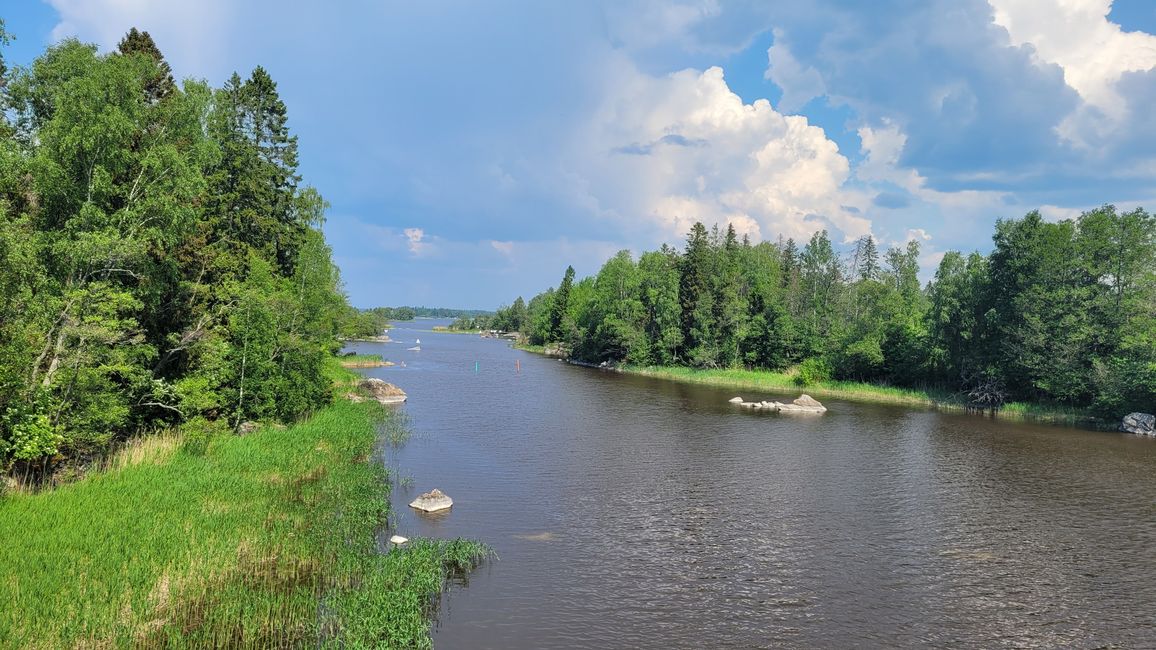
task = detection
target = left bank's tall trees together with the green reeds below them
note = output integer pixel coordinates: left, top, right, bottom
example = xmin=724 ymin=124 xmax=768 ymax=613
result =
xmin=0 ymin=22 xmax=487 ymax=648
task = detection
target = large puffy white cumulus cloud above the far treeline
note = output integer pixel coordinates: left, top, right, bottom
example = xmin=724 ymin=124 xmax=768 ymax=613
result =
xmin=577 ymin=67 xmax=870 ymax=241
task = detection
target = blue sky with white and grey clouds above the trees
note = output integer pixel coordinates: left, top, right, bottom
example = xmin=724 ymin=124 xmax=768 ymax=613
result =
xmin=0 ymin=0 xmax=1156 ymax=309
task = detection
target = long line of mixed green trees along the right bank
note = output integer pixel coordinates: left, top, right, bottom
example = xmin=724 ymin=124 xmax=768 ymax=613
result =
xmin=510 ymin=206 xmax=1156 ymax=416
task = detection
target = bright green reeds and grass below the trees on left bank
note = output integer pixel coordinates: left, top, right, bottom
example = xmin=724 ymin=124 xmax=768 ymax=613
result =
xmin=0 ymin=369 xmax=488 ymax=648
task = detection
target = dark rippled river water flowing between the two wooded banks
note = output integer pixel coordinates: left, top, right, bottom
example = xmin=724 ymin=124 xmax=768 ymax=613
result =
xmin=350 ymin=320 xmax=1156 ymax=649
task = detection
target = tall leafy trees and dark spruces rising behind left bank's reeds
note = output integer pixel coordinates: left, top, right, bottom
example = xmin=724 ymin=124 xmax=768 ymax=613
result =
xmin=0 ymin=25 xmax=347 ymax=468
